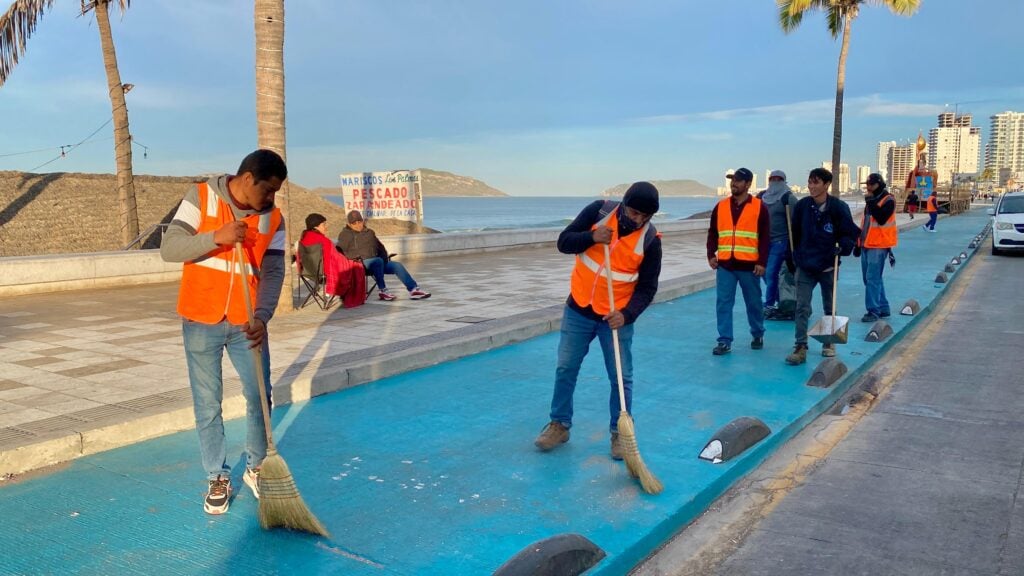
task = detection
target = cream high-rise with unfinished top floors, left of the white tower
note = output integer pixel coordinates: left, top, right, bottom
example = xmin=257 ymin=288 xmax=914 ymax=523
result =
xmin=928 ymin=112 xmax=981 ymax=183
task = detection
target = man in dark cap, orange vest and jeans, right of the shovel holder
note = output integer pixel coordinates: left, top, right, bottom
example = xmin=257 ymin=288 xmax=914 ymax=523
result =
xmin=854 ymin=170 xmax=897 ymax=322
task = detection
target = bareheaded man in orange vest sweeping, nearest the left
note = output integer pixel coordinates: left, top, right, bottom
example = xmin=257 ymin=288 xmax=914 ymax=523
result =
xmin=160 ymin=150 xmax=288 ymax=515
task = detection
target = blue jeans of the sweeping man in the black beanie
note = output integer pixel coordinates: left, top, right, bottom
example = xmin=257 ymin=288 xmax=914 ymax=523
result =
xmin=551 ymin=305 xmax=633 ymax=431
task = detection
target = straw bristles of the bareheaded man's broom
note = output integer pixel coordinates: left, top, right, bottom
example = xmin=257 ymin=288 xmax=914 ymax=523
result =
xmin=259 ymin=449 xmax=330 ymax=537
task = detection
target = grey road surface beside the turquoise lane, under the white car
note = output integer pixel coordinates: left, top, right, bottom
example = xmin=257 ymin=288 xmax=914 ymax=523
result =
xmin=635 ymin=240 xmax=1024 ymax=576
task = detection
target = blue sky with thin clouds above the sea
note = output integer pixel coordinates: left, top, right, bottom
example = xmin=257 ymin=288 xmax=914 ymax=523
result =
xmin=0 ymin=0 xmax=1024 ymax=196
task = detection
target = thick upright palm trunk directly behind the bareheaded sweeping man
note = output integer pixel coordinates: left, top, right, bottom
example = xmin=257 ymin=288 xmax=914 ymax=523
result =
xmin=253 ymin=0 xmax=295 ymax=312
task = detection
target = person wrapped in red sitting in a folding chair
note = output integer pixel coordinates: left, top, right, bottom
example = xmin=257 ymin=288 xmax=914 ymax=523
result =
xmin=299 ymin=212 xmax=367 ymax=310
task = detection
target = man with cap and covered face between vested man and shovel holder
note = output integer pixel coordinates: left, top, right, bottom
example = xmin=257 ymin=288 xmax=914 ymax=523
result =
xmin=758 ymin=170 xmax=797 ymax=320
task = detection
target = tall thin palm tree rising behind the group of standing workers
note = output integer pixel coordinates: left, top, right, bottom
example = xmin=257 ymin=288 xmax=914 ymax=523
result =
xmin=775 ymin=0 xmax=921 ymax=196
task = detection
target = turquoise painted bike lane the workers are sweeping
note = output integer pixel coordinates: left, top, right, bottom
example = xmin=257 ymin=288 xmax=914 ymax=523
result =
xmin=0 ymin=211 xmax=987 ymax=576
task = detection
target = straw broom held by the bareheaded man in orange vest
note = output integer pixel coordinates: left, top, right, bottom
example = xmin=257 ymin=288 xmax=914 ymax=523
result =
xmin=234 ymin=243 xmax=330 ymax=536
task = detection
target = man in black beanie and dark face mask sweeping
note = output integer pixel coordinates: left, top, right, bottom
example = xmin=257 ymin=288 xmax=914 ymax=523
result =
xmin=534 ymin=182 xmax=662 ymax=460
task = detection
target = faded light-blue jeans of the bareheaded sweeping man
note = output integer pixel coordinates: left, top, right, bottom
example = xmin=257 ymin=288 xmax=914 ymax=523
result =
xmin=181 ymin=320 xmax=270 ymax=480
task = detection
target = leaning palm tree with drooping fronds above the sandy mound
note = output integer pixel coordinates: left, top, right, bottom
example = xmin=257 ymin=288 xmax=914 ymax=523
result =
xmin=0 ymin=0 xmax=138 ymax=246
